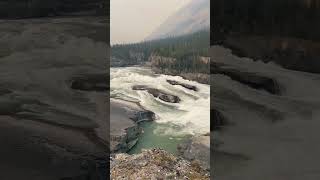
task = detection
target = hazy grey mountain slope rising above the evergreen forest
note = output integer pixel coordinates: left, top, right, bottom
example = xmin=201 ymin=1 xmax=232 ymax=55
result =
xmin=145 ymin=0 xmax=210 ymax=40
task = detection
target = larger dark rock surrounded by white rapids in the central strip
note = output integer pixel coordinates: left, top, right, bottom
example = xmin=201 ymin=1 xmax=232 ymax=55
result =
xmin=132 ymin=85 xmax=181 ymax=103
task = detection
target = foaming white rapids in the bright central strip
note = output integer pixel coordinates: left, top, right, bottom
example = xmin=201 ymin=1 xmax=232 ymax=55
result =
xmin=110 ymin=67 xmax=210 ymax=136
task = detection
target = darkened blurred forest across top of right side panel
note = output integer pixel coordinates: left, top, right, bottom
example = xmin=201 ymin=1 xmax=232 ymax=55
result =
xmin=211 ymin=0 xmax=320 ymax=41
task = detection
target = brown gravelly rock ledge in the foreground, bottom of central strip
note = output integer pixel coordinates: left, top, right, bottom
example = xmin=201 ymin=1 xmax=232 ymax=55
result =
xmin=110 ymin=149 xmax=210 ymax=180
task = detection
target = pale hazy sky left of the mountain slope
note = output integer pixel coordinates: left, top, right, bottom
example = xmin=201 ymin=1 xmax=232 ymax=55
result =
xmin=110 ymin=0 xmax=191 ymax=44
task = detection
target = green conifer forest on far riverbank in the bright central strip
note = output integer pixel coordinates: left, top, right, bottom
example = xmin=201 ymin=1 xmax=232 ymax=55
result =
xmin=111 ymin=30 xmax=210 ymax=73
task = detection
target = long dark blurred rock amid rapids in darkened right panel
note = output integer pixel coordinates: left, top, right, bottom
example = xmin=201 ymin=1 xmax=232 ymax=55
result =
xmin=210 ymin=63 xmax=281 ymax=95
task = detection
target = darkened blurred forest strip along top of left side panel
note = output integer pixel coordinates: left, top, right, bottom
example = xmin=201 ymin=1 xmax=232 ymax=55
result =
xmin=0 ymin=0 xmax=109 ymax=18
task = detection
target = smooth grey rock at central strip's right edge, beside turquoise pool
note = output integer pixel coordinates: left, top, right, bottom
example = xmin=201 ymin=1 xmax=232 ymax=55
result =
xmin=178 ymin=135 xmax=210 ymax=170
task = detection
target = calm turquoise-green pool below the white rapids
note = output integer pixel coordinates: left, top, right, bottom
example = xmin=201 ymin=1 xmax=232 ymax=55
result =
xmin=128 ymin=122 xmax=189 ymax=154
